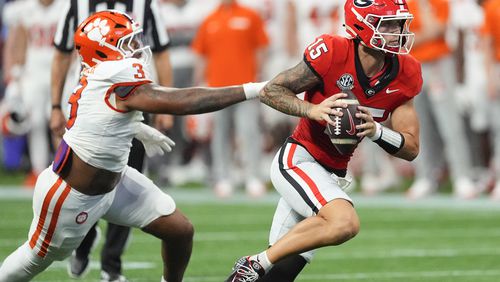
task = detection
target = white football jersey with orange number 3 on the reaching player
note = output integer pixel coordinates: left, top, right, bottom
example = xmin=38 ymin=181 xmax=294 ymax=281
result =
xmin=63 ymin=58 xmax=151 ymax=172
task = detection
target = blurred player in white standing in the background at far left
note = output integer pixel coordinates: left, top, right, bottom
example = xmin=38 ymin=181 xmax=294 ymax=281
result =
xmin=3 ymin=0 xmax=63 ymax=185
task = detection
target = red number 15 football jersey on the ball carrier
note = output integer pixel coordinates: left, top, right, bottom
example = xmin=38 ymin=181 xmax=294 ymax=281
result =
xmin=292 ymin=34 xmax=422 ymax=169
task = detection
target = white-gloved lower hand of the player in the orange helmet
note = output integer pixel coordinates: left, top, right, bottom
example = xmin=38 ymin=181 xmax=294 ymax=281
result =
xmin=135 ymin=123 xmax=175 ymax=157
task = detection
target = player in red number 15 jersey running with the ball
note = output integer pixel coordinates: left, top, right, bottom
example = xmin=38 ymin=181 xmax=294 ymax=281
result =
xmin=227 ymin=0 xmax=422 ymax=282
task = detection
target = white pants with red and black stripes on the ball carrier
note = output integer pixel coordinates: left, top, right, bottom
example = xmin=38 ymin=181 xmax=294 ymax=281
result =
xmin=269 ymin=138 xmax=352 ymax=261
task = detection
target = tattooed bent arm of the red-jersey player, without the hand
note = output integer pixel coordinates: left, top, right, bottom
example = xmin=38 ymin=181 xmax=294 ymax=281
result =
xmin=260 ymin=61 xmax=321 ymax=117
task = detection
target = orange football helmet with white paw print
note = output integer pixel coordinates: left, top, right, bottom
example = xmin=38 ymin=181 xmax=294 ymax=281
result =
xmin=74 ymin=10 xmax=151 ymax=67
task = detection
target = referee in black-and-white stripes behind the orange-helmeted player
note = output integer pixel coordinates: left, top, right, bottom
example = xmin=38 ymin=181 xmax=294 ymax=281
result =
xmin=50 ymin=0 xmax=172 ymax=282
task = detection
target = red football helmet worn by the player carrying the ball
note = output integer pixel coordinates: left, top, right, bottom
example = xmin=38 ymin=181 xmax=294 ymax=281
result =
xmin=344 ymin=0 xmax=415 ymax=54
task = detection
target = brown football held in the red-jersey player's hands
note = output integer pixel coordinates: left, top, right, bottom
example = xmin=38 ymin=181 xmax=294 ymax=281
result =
xmin=325 ymin=96 xmax=363 ymax=155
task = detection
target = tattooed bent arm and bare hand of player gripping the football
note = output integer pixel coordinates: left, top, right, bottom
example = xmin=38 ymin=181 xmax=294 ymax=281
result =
xmin=260 ymin=61 xmax=347 ymax=124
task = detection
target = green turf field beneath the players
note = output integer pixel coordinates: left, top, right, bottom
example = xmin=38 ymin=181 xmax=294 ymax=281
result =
xmin=0 ymin=188 xmax=500 ymax=282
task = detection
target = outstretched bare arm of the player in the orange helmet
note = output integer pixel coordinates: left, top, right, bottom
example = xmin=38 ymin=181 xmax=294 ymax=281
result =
xmin=117 ymin=83 xmax=258 ymax=115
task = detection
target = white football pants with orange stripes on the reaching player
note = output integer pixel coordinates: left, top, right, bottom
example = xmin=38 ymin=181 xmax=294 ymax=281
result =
xmin=0 ymin=166 xmax=175 ymax=282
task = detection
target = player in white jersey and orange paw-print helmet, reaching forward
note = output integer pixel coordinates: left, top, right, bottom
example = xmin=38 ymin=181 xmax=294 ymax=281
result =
xmin=0 ymin=11 xmax=286 ymax=282
